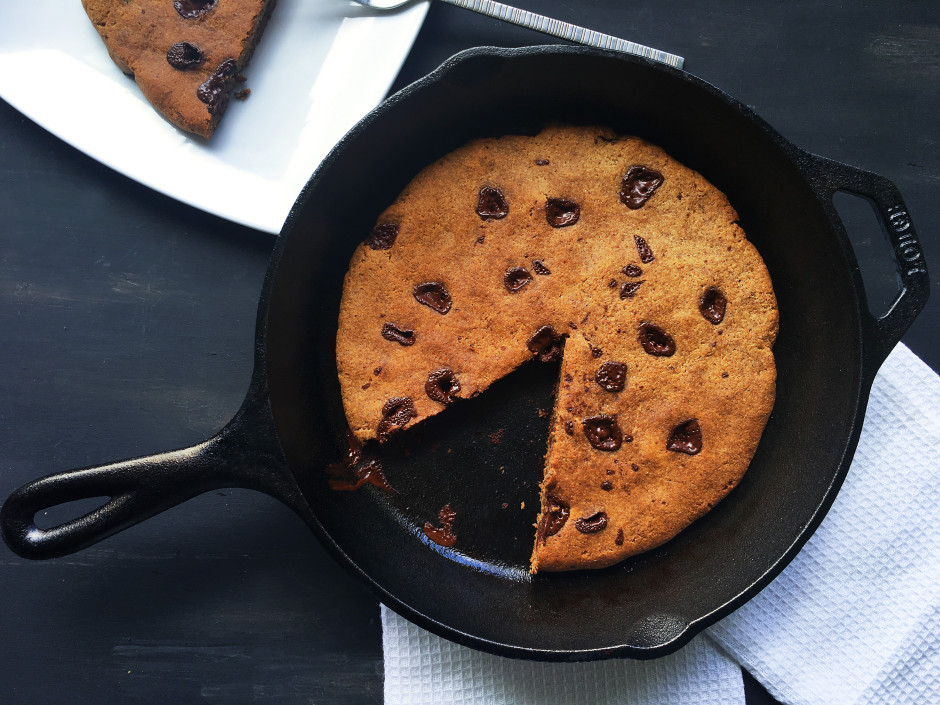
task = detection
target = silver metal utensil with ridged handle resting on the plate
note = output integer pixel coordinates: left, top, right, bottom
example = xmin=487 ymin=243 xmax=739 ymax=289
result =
xmin=353 ymin=0 xmax=685 ymax=69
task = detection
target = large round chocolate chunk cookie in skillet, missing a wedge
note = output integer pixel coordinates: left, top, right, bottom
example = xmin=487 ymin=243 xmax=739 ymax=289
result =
xmin=336 ymin=127 xmax=777 ymax=572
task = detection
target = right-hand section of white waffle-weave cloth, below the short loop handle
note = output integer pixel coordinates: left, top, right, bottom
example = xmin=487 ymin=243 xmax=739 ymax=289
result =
xmin=709 ymin=345 xmax=940 ymax=705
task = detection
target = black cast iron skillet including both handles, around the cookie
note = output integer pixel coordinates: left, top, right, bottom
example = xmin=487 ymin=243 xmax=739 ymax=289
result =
xmin=0 ymin=46 xmax=928 ymax=661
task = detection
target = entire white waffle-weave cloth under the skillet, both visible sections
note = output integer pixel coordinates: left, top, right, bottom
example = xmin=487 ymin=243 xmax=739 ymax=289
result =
xmin=382 ymin=345 xmax=940 ymax=705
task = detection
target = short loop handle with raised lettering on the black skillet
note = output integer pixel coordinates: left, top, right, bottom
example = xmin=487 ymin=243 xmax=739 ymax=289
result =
xmin=810 ymin=155 xmax=930 ymax=364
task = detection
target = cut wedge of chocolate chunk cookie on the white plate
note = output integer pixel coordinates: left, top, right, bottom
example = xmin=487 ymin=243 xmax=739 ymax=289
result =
xmin=82 ymin=0 xmax=275 ymax=138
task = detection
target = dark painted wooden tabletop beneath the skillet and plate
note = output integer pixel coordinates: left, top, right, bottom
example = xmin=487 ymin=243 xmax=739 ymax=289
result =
xmin=0 ymin=0 xmax=940 ymax=705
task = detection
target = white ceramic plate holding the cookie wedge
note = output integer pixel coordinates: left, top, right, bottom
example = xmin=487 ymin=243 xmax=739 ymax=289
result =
xmin=0 ymin=0 xmax=428 ymax=233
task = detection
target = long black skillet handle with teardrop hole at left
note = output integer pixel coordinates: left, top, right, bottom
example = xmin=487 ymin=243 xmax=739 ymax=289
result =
xmin=0 ymin=385 xmax=299 ymax=559
